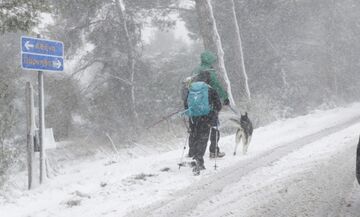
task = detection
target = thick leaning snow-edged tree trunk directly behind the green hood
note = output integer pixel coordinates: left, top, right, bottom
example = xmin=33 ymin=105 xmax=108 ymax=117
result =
xmin=195 ymin=0 xmax=235 ymax=105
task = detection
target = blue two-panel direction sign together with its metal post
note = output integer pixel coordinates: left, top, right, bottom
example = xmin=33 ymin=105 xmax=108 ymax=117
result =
xmin=21 ymin=35 xmax=64 ymax=184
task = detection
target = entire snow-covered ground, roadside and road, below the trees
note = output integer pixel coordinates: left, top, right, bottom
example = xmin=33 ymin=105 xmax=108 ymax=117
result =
xmin=0 ymin=104 xmax=360 ymax=217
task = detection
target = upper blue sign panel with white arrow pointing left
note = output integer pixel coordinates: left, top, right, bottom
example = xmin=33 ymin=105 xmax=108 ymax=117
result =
xmin=21 ymin=36 xmax=64 ymax=57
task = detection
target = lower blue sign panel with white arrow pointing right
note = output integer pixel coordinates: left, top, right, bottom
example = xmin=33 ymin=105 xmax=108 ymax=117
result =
xmin=21 ymin=53 xmax=64 ymax=72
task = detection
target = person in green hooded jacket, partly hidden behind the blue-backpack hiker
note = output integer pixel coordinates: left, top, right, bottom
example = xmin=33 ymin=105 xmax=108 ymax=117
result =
xmin=186 ymin=51 xmax=230 ymax=158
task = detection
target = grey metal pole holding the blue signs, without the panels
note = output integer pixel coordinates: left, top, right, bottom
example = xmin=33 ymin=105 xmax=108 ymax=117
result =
xmin=37 ymin=34 xmax=45 ymax=184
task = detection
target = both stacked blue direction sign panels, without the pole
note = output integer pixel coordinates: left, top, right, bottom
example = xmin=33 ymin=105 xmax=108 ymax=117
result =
xmin=21 ymin=36 xmax=64 ymax=72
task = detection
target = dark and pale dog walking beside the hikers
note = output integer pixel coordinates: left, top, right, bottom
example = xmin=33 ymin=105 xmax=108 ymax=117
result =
xmin=230 ymin=112 xmax=254 ymax=155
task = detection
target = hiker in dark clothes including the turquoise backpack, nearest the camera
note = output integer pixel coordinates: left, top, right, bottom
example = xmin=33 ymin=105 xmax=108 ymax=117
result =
xmin=184 ymin=71 xmax=221 ymax=175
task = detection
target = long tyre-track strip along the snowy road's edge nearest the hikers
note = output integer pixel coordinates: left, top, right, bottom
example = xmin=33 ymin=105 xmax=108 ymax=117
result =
xmin=127 ymin=117 xmax=360 ymax=217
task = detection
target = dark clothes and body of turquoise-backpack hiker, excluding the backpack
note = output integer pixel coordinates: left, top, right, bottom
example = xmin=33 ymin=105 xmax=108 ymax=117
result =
xmin=185 ymin=71 xmax=222 ymax=175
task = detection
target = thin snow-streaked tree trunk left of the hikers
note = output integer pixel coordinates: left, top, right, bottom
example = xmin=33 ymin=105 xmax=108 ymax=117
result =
xmin=115 ymin=0 xmax=138 ymax=120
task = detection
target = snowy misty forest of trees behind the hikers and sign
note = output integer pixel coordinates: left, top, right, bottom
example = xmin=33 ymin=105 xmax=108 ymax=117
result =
xmin=0 ymin=0 xmax=360 ymax=184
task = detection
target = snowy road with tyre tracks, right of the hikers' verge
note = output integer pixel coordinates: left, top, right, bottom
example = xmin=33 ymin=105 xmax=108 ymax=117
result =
xmin=129 ymin=118 xmax=360 ymax=217
